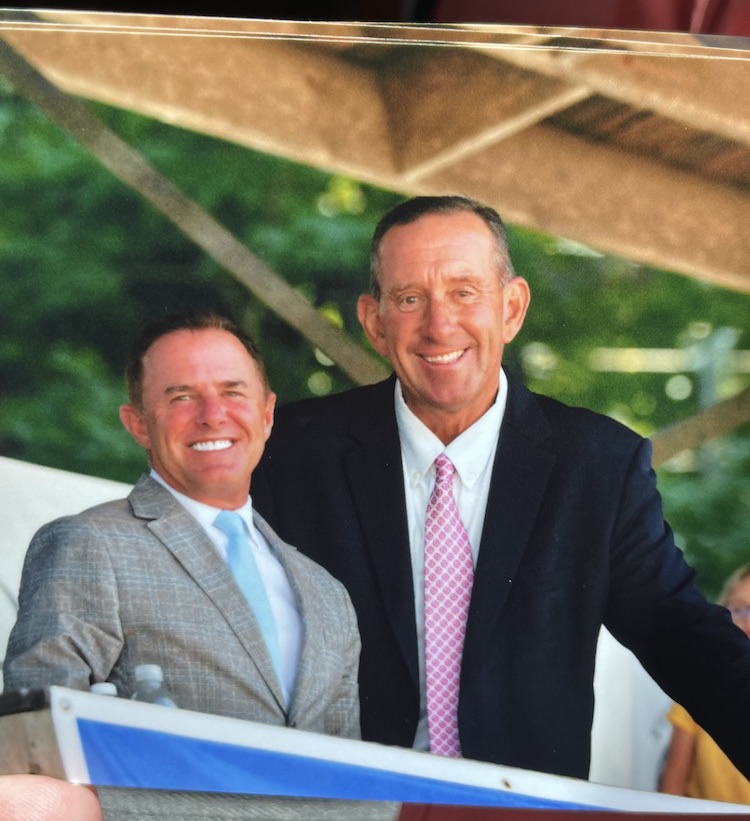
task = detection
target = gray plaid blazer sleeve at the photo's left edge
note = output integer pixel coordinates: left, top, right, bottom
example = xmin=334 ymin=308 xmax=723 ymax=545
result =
xmin=3 ymin=518 xmax=123 ymax=690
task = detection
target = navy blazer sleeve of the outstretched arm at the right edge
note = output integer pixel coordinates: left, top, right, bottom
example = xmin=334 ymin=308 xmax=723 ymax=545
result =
xmin=605 ymin=441 xmax=750 ymax=777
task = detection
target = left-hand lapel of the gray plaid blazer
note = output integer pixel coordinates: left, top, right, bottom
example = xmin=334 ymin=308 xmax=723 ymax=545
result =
xmin=129 ymin=476 xmax=286 ymax=711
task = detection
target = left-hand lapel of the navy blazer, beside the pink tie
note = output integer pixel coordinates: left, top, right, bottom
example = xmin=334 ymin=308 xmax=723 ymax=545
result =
xmin=344 ymin=377 xmax=419 ymax=686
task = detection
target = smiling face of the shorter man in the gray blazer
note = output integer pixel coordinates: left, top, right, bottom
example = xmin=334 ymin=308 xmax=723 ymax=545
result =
xmin=120 ymin=329 xmax=276 ymax=509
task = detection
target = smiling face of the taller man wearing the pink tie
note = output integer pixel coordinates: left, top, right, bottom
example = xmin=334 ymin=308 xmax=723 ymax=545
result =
xmin=358 ymin=212 xmax=529 ymax=442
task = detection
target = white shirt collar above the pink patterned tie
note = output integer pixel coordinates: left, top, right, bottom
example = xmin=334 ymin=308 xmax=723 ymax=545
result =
xmin=394 ymin=370 xmax=508 ymax=488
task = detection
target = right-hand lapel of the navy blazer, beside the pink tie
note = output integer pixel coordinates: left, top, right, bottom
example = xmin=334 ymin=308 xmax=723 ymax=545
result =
xmin=465 ymin=380 xmax=555 ymax=658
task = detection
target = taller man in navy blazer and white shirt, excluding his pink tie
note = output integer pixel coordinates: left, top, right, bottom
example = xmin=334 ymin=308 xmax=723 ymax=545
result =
xmin=253 ymin=197 xmax=750 ymax=778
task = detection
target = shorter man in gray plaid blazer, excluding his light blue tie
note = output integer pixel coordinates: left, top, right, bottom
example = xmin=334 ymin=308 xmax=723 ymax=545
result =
xmin=4 ymin=316 xmax=359 ymax=738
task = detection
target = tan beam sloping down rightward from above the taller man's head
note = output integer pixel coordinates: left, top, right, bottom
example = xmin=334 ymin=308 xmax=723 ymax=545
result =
xmin=420 ymin=126 xmax=750 ymax=292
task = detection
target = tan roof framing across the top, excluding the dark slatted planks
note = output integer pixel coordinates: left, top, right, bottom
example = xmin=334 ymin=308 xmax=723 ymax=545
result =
xmin=5 ymin=15 xmax=750 ymax=292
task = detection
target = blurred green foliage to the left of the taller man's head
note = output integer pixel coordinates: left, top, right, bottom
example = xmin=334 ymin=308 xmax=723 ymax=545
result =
xmin=0 ymin=89 xmax=398 ymax=481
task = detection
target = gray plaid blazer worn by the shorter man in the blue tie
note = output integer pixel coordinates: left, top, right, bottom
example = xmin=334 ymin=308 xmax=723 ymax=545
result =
xmin=4 ymin=476 xmax=360 ymax=738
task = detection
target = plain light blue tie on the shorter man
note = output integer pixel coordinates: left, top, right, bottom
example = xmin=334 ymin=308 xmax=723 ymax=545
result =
xmin=214 ymin=510 xmax=281 ymax=680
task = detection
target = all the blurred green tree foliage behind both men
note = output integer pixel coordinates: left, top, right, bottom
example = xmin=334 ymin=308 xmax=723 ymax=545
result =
xmin=0 ymin=87 xmax=750 ymax=595
